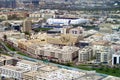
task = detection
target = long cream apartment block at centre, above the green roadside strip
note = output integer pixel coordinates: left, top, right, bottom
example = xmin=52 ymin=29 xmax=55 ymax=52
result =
xmin=36 ymin=45 xmax=79 ymax=63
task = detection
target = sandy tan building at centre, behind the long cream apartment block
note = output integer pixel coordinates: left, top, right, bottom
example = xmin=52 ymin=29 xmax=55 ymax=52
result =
xmin=47 ymin=34 xmax=82 ymax=45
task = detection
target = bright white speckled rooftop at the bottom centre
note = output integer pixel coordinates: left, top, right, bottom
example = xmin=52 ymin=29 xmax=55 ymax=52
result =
xmin=38 ymin=69 xmax=85 ymax=80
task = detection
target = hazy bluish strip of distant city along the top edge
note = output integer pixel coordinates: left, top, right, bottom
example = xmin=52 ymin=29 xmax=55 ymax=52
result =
xmin=0 ymin=0 xmax=120 ymax=10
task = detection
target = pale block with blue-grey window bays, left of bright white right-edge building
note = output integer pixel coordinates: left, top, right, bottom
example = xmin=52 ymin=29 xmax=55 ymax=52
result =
xmin=93 ymin=41 xmax=113 ymax=63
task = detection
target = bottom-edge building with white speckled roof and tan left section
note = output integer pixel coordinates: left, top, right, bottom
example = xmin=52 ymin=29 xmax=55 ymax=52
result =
xmin=23 ymin=69 xmax=86 ymax=80
